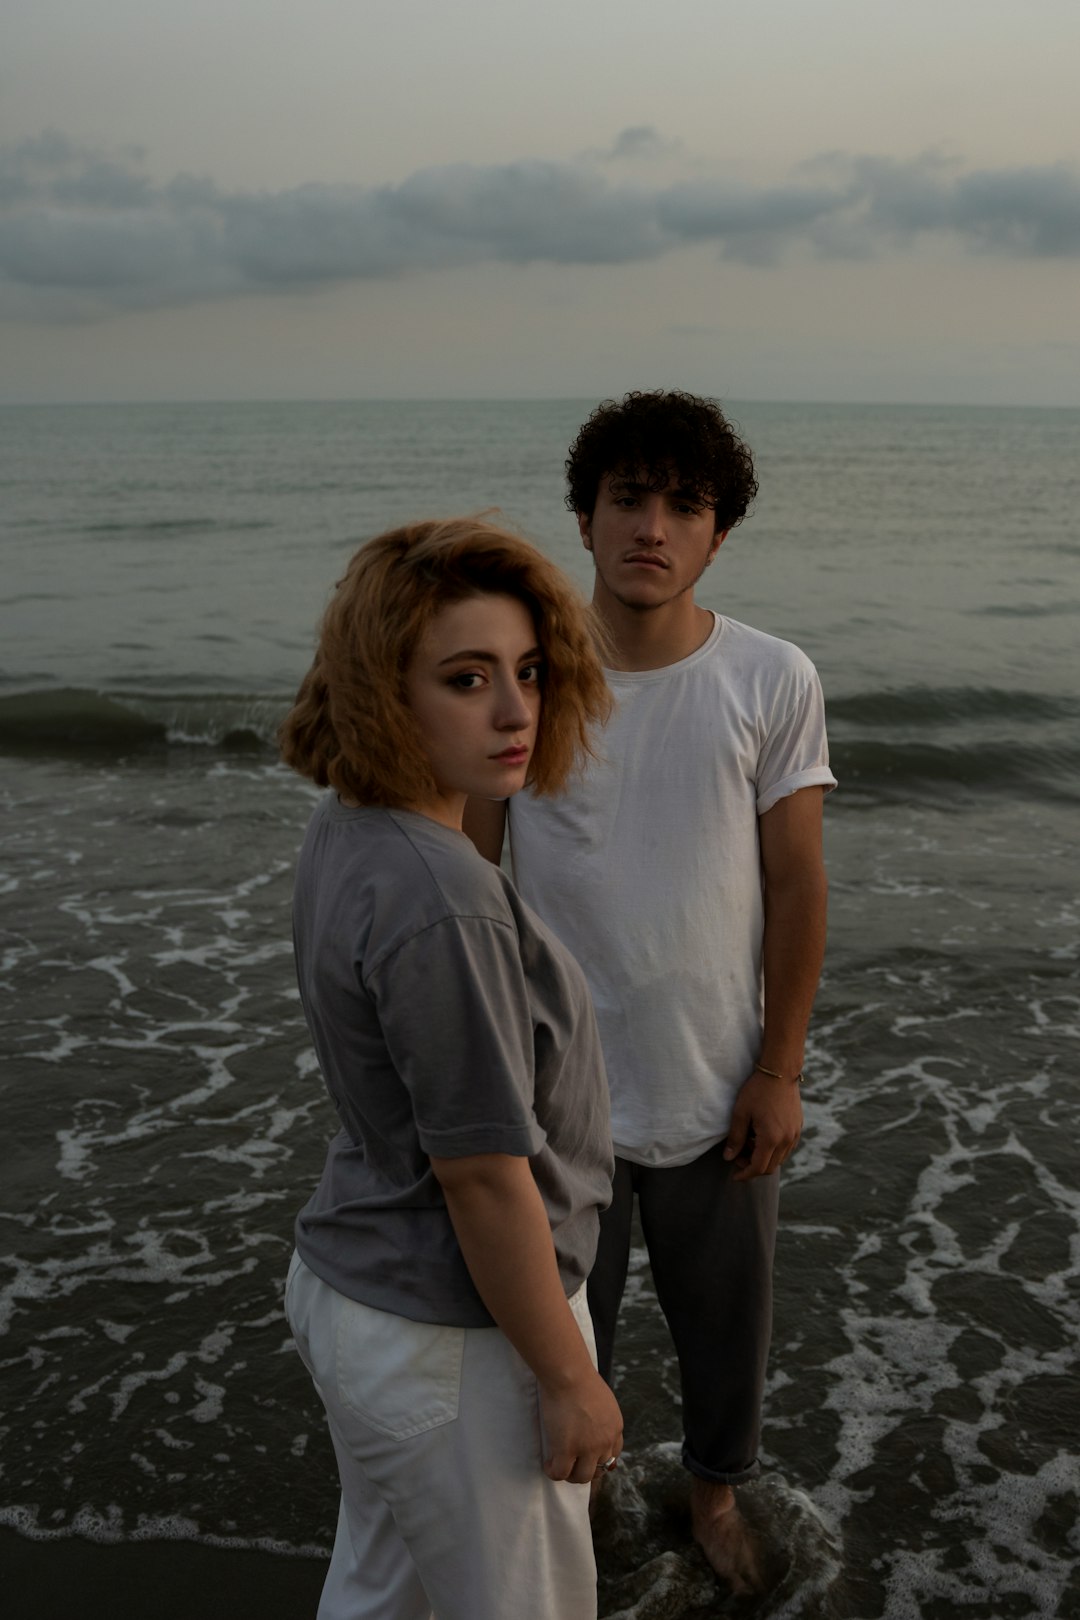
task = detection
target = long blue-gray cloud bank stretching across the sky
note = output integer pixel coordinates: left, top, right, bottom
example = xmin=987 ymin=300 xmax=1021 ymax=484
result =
xmin=0 ymin=128 xmax=1080 ymax=319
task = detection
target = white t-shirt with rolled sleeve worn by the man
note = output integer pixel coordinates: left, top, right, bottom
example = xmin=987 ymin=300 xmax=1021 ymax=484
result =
xmin=508 ymin=614 xmax=836 ymax=1165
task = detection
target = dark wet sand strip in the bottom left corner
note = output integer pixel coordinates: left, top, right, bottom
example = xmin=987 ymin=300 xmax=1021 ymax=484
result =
xmin=0 ymin=1529 xmax=327 ymax=1620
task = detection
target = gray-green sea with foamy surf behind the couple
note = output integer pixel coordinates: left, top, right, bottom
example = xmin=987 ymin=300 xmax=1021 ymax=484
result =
xmin=0 ymin=400 xmax=1080 ymax=1620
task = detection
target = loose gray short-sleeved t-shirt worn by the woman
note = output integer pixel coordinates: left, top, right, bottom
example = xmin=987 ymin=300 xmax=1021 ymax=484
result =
xmin=293 ymin=795 xmax=612 ymax=1327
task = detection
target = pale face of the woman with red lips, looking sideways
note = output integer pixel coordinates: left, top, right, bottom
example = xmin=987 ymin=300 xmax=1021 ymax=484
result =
xmin=405 ymin=595 xmax=541 ymax=828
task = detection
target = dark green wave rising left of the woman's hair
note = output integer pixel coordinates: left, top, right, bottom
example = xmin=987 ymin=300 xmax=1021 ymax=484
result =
xmin=0 ymin=687 xmax=288 ymax=755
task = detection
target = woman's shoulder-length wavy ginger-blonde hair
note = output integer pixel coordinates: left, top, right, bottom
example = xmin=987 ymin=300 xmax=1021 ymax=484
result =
xmin=279 ymin=517 xmax=610 ymax=805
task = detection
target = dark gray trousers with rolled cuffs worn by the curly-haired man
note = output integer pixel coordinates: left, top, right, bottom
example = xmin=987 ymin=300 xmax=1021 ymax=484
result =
xmin=589 ymin=1142 xmax=780 ymax=1484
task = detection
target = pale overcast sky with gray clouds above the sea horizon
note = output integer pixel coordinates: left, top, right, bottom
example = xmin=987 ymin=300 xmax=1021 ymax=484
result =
xmin=0 ymin=0 xmax=1080 ymax=407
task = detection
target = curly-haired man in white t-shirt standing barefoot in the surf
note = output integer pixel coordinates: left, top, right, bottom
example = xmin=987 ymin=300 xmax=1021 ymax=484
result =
xmin=466 ymin=392 xmax=836 ymax=1591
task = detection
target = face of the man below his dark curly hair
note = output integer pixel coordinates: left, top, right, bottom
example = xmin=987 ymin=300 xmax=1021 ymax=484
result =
xmin=578 ymin=473 xmax=727 ymax=612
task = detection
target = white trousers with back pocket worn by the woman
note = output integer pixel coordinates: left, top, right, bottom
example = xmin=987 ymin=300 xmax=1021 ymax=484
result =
xmin=285 ymin=1254 xmax=596 ymax=1620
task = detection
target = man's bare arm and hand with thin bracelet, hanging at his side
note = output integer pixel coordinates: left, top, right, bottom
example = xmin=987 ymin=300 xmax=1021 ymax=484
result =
xmin=724 ymin=787 xmax=829 ymax=1181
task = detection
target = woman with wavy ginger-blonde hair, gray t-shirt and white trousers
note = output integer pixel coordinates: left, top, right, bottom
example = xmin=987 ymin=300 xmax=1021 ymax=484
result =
xmin=282 ymin=518 xmax=622 ymax=1620
